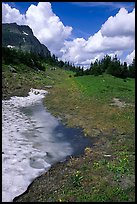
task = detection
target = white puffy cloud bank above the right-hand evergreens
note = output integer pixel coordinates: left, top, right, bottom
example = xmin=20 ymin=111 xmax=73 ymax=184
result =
xmin=62 ymin=8 xmax=135 ymax=64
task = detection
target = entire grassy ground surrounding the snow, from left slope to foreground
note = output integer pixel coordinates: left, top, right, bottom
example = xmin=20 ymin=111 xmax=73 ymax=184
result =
xmin=2 ymin=63 xmax=135 ymax=202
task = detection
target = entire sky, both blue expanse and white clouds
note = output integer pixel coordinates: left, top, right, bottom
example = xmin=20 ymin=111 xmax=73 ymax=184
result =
xmin=2 ymin=2 xmax=135 ymax=67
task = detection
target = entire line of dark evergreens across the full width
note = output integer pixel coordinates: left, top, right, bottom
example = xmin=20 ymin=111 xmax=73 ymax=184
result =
xmin=2 ymin=47 xmax=135 ymax=78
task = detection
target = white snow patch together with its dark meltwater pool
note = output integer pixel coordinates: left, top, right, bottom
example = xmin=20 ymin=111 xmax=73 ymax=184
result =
xmin=2 ymin=89 xmax=91 ymax=202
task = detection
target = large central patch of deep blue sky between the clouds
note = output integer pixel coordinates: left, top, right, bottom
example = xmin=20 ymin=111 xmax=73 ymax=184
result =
xmin=52 ymin=2 xmax=134 ymax=38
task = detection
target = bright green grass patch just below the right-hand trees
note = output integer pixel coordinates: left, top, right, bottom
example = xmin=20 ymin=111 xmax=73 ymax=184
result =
xmin=75 ymin=75 xmax=135 ymax=103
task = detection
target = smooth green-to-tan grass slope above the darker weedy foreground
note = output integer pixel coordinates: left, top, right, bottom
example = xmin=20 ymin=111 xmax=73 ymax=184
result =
xmin=46 ymin=72 xmax=135 ymax=136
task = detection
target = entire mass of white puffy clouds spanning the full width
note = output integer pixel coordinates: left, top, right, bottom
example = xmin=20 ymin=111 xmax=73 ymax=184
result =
xmin=2 ymin=2 xmax=135 ymax=66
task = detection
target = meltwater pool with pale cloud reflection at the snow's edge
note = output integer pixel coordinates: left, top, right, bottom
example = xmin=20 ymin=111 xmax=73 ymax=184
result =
xmin=21 ymin=103 xmax=91 ymax=165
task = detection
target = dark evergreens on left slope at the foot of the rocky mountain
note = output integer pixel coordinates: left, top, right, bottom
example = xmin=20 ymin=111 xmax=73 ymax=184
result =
xmin=2 ymin=47 xmax=76 ymax=71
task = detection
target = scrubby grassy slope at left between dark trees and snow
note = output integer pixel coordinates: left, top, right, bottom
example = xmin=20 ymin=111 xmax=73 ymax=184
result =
xmin=2 ymin=64 xmax=54 ymax=99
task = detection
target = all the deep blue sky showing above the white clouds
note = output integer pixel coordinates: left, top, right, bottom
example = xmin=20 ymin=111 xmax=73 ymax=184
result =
xmin=5 ymin=2 xmax=135 ymax=38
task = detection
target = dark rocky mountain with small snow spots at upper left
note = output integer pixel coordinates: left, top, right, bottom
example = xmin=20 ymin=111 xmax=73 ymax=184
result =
xmin=2 ymin=23 xmax=50 ymax=57
